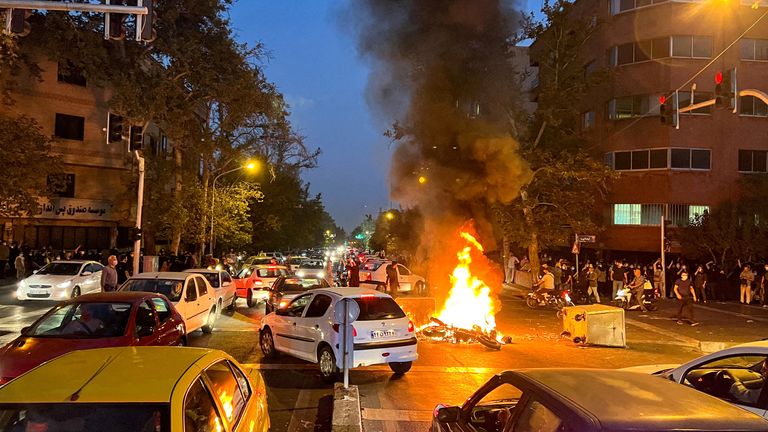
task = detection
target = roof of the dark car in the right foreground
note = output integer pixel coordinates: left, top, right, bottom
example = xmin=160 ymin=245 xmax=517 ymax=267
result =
xmin=510 ymin=369 xmax=768 ymax=431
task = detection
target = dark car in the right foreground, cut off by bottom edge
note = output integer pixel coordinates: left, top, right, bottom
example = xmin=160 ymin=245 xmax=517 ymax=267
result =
xmin=432 ymin=369 xmax=768 ymax=432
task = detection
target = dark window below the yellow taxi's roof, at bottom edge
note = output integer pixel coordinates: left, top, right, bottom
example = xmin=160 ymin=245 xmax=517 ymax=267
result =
xmin=0 ymin=402 xmax=170 ymax=432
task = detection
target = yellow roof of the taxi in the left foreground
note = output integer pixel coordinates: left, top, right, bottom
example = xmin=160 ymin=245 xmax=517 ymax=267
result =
xmin=0 ymin=347 xmax=222 ymax=403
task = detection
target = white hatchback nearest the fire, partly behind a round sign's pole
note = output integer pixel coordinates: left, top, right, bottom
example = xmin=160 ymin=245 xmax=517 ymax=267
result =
xmin=259 ymin=287 xmax=419 ymax=381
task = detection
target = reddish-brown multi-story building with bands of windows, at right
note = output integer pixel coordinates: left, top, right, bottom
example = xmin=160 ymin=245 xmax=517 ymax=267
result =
xmin=534 ymin=0 xmax=768 ymax=252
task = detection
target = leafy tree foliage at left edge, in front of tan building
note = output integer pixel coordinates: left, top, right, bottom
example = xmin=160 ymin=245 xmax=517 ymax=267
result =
xmin=0 ymin=115 xmax=62 ymax=216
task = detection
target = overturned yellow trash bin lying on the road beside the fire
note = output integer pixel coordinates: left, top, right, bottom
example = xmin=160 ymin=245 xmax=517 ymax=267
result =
xmin=563 ymin=304 xmax=627 ymax=348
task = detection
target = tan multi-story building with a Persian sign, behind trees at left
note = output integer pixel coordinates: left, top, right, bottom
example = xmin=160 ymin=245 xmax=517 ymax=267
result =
xmin=0 ymin=60 xmax=167 ymax=250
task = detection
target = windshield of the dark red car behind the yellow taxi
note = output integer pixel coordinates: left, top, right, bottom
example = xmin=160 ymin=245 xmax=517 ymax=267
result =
xmin=25 ymin=302 xmax=131 ymax=339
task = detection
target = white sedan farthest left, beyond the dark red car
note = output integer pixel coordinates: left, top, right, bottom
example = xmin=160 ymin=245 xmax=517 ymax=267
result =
xmin=16 ymin=261 xmax=104 ymax=301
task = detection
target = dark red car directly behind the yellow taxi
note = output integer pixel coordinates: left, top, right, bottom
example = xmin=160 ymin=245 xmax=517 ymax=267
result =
xmin=0 ymin=292 xmax=186 ymax=384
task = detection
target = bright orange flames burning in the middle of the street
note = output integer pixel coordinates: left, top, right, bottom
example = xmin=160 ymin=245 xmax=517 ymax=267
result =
xmin=437 ymin=231 xmax=498 ymax=334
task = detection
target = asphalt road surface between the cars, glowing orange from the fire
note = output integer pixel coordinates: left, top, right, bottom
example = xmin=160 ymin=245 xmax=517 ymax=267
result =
xmin=0 ymin=278 xmax=768 ymax=432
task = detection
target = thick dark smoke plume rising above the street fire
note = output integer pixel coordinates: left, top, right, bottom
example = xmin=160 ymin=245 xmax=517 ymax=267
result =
xmin=345 ymin=0 xmax=530 ymax=292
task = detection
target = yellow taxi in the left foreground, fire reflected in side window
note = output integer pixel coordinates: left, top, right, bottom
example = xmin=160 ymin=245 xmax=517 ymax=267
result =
xmin=0 ymin=347 xmax=269 ymax=432
